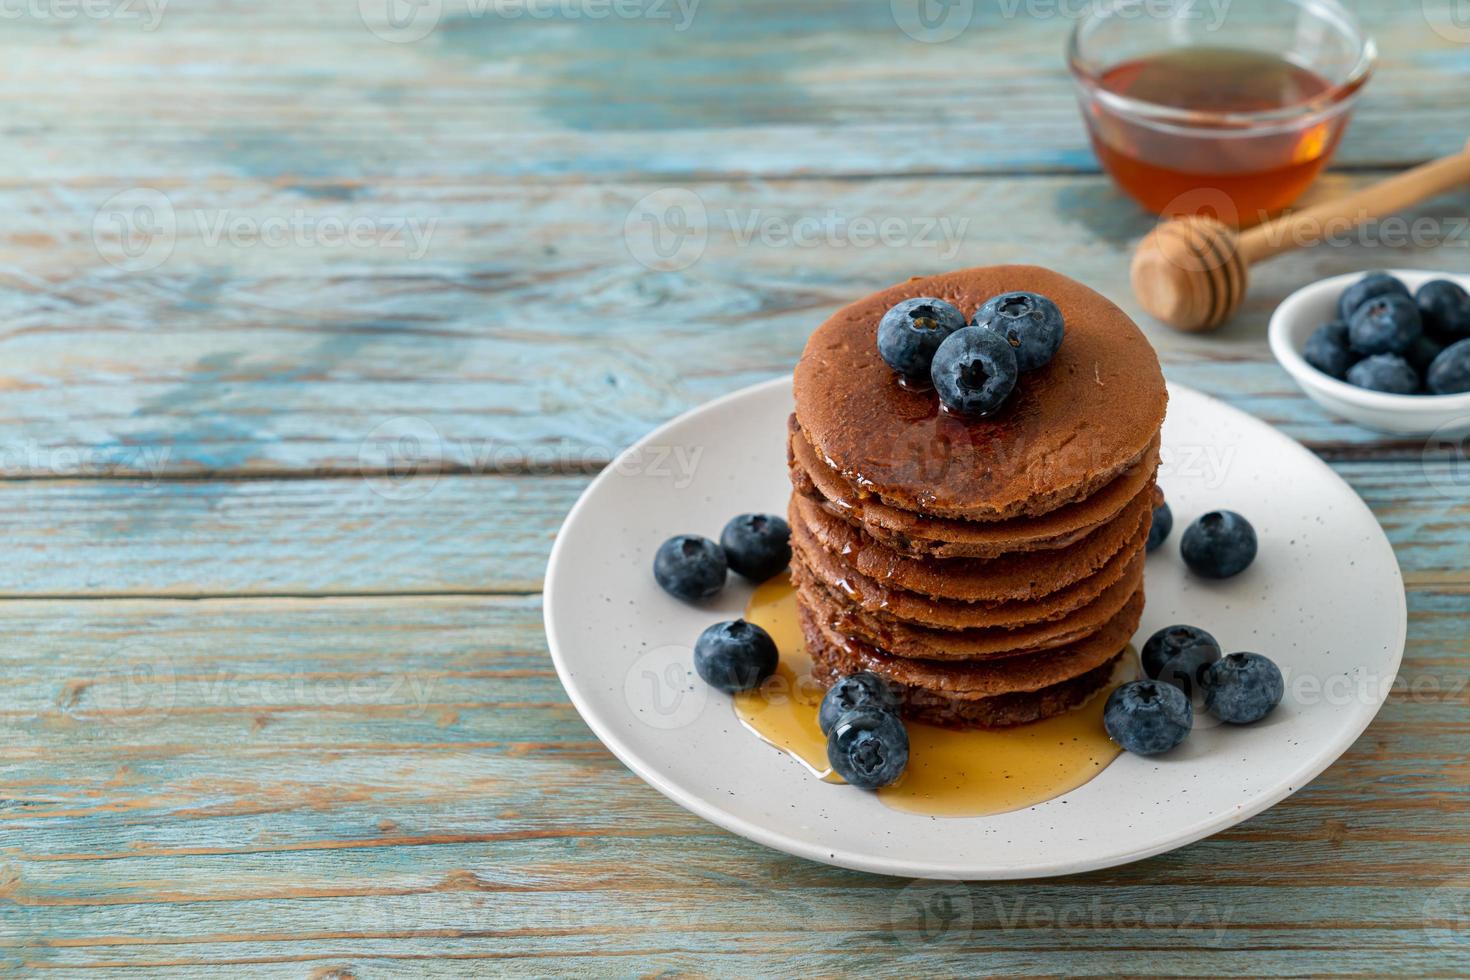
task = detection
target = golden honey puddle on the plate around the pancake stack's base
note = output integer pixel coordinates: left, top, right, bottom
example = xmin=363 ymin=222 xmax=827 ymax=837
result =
xmin=735 ymin=576 xmax=1138 ymax=817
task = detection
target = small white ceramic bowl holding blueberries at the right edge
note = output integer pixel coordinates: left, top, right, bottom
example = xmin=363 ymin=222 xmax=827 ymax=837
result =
xmin=1270 ymin=269 xmax=1470 ymax=436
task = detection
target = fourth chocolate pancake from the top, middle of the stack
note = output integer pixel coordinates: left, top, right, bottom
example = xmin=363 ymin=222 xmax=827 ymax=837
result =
xmin=791 ymin=502 xmax=1148 ymax=629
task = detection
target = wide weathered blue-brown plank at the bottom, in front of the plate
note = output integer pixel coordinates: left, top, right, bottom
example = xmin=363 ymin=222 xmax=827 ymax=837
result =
xmin=0 ymin=591 xmax=1470 ymax=976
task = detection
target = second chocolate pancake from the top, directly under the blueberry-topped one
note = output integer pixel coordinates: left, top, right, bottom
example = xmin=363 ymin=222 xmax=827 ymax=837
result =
xmin=786 ymin=416 xmax=1158 ymax=558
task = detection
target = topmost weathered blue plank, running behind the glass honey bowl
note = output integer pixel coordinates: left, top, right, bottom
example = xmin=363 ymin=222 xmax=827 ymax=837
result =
xmin=0 ymin=0 xmax=1470 ymax=182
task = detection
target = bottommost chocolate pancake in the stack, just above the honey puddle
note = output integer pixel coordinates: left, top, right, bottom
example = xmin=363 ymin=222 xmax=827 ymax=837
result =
xmin=797 ymin=602 xmax=1142 ymax=729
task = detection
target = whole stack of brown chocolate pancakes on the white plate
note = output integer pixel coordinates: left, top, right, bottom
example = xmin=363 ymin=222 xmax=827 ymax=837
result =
xmin=788 ymin=266 xmax=1167 ymax=727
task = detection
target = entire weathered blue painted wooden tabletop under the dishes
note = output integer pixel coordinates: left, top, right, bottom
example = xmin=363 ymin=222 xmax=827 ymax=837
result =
xmin=0 ymin=0 xmax=1470 ymax=977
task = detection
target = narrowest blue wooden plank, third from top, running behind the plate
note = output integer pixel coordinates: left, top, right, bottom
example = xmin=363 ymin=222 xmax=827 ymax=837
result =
xmin=0 ymin=461 xmax=1470 ymax=598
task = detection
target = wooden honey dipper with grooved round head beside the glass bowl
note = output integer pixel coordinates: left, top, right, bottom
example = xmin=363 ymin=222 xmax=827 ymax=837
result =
xmin=1130 ymin=144 xmax=1470 ymax=332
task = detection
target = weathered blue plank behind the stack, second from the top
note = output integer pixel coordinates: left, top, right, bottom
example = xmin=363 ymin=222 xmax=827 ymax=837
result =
xmin=0 ymin=178 xmax=1470 ymax=478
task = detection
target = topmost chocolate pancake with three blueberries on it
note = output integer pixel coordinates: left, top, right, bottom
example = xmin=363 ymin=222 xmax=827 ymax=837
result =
xmin=795 ymin=266 xmax=1167 ymax=520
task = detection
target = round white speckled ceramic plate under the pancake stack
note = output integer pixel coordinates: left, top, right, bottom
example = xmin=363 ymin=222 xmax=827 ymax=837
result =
xmin=545 ymin=378 xmax=1407 ymax=879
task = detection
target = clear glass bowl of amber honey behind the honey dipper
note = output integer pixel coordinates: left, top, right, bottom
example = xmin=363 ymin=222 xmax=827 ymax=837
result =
xmin=1067 ymin=0 xmax=1377 ymax=228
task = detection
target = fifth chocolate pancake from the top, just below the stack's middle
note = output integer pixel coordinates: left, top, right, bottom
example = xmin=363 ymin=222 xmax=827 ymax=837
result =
xmin=792 ymin=543 xmax=1144 ymax=660
